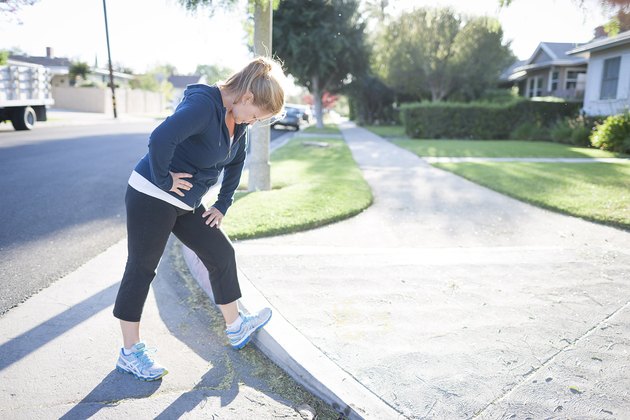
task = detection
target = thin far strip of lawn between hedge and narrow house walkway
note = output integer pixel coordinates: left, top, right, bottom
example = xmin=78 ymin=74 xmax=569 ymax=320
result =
xmin=392 ymin=139 xmax=625 ymax=158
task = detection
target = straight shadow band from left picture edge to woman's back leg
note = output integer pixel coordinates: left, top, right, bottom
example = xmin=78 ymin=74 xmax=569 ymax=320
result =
xmin=0 ymin=283 xmax=120 ymax=371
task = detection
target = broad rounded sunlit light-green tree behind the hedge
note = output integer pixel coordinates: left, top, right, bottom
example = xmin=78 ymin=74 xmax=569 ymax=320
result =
xmin=374 ymin=8 xmax=512 ymax=101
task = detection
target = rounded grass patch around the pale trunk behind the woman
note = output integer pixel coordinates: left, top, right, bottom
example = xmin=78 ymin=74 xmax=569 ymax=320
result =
xmin=210 ymin=136 xmax=372 ymax=240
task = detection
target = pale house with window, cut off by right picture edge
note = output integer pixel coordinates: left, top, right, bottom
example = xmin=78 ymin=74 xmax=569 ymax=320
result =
xmin=568 ymin=31 xmax=630 ymax=115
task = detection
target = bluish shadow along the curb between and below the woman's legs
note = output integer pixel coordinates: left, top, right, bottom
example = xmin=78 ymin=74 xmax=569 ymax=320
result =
xmin=152 ymin=237 xmax=316 ymax=419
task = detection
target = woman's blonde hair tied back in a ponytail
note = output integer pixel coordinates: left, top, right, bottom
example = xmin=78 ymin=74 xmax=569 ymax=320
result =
xmin=220 ymin=56 xmax=286 ymax=115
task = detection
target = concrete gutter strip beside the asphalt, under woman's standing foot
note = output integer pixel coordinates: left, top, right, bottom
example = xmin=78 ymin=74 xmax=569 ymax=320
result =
xmin=0 ymin=241 xmax=337 ymax=420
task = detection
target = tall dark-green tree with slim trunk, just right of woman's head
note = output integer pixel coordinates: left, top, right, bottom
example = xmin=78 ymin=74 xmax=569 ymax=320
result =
xmin=273 ymin=0 xmax=369 ymax=127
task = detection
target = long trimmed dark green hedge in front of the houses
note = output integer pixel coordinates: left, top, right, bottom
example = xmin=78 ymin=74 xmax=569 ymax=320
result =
xmin=401 ymin=100 xmax=580 ymax=140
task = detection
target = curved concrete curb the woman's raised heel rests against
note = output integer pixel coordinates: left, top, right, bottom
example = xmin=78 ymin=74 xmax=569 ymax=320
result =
xmin=182 ymin=247 xmax=404 ymax=420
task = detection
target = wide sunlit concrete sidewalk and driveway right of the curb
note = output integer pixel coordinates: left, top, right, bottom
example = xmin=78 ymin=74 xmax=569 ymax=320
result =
xmin=209 ymin=124 xmax=630 ymax=419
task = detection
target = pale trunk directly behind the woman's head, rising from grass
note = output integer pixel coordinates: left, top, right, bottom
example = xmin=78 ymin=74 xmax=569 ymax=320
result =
xmin=248 ymin=0 xmax=272 ymax=191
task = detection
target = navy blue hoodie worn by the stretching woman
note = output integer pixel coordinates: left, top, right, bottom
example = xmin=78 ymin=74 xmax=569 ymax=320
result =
xmin=135 ymin=84 xmax=247 ymax=214
